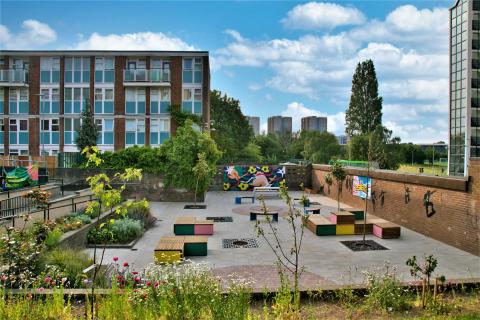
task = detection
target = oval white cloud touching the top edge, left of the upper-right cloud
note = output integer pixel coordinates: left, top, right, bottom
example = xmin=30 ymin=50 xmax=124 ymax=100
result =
xmin=282 ymin=2 xmax=366 ymax=30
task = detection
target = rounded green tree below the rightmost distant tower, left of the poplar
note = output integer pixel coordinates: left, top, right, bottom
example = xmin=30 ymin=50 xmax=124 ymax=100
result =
xmin=304 ymin=131 xmax=341 ymax=163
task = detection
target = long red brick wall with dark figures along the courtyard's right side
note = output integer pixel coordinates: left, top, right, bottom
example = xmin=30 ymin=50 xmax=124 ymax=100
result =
xmin=312 ymin=159 xmax=480 ymax=256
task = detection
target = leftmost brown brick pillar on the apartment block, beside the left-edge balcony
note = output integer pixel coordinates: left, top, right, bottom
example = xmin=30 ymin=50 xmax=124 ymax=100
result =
xmin=28 ymin=57 xmax=40 ymax=156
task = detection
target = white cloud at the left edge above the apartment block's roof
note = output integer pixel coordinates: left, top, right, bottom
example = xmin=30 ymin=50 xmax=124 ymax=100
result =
xmin=0 ymin=19 xmax=57 ymax=50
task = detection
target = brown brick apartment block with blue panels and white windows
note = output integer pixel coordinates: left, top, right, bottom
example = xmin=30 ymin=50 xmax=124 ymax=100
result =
xmin=0 ymin=51 xmax=210 ymax=156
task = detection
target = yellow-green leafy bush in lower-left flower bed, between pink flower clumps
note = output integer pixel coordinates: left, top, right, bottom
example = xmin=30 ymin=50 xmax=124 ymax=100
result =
xmin=43 ymin=248 xmax=92 ymax=287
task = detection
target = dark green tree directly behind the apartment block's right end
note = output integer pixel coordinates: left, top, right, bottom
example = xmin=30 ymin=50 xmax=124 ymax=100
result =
xmin=210 ymin=90 xmax=253 ymax=162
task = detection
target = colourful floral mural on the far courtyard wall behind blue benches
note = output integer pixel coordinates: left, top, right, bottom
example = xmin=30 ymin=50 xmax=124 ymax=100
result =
xmin=223 ymin=166 xmax=285 ymax=191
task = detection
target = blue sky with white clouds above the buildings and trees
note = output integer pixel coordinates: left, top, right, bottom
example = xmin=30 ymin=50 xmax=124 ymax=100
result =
xmin=0 ymin=0 xmax=454 ymax=143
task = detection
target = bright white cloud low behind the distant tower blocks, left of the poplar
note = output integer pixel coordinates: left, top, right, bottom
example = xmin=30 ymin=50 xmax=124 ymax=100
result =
xmin=282 ymin=101 xmax=345 ymax=135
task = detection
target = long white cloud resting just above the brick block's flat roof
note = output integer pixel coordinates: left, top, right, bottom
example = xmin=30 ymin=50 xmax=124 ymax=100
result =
xmin=75 ymin=32 xmax=195 ymax=51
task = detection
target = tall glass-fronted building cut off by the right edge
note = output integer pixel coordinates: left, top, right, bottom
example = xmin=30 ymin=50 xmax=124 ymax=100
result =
xmin=448 ymin=0 xmax=480 ymax=176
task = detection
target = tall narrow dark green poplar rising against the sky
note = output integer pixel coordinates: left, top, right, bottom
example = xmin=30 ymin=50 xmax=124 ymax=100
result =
xmin=345 ymin=60 xmax=382 ymax=137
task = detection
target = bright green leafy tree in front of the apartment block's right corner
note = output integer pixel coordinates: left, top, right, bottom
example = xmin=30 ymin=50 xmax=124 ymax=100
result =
xmin=160 ymin=119 xmax=222 ymax=193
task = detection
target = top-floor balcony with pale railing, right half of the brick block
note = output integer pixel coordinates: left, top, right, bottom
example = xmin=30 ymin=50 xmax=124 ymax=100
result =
xmin=123 ymin=69 xmax=170 ymax=86
